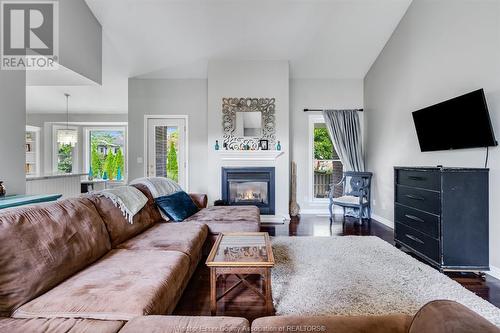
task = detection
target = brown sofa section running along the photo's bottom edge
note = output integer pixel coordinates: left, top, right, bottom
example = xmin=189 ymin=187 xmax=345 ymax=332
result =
xmin=0 ymin=301 xmax=500 ymax=333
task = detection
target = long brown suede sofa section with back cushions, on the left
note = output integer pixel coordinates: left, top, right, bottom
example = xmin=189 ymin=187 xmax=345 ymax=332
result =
xmin=0 ymin=185 xmax=260 ymax=332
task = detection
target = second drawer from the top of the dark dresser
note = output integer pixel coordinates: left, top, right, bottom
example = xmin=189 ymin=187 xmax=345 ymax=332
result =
xmin=396 ymin=185 xmax=441 ymax=215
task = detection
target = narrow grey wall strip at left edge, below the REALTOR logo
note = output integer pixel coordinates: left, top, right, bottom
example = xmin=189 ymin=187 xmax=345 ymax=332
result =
xmin=0 ymin=70 xmax=26 ymax=194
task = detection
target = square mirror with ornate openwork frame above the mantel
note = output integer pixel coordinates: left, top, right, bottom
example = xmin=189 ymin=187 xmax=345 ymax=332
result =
xmin=222 ymin=98 xmax=276 ymax=150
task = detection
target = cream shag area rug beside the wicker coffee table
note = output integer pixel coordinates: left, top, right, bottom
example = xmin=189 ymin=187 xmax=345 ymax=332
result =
xmin=272 ymin=236 xmax=500 ymax=326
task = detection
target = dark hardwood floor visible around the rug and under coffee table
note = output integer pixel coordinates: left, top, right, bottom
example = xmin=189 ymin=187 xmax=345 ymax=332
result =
xmin=174 ymin=215 xmax=500 ymax=321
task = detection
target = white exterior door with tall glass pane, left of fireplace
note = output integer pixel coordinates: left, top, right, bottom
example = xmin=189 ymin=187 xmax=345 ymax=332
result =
xmin=146 ymin=118 xmax=187 ymax=190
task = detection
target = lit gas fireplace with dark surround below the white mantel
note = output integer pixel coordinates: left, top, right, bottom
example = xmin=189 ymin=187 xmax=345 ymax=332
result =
xmin=222 ymin=168 xmax=275 ymax=215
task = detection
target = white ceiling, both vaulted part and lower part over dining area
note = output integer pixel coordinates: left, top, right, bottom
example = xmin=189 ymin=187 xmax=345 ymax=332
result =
xmin=28 ymin=0 xmax=411 ymax=113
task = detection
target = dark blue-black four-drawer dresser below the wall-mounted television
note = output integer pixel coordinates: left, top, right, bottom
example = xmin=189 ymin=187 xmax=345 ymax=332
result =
xmin=394 ymin=167 xmax=489 ymax=272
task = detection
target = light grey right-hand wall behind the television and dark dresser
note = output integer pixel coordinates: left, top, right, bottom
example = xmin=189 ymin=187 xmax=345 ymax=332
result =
xmin=365 ymin=0 xmax=500 ymax=267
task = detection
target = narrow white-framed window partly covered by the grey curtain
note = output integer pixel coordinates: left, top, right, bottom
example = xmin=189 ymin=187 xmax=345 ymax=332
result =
xmin=309 ymin=116 xmax=343 ymax=201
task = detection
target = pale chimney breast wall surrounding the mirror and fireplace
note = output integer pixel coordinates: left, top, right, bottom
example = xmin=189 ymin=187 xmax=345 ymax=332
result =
xmin=205 ymin=60 xmax=290 ymax=215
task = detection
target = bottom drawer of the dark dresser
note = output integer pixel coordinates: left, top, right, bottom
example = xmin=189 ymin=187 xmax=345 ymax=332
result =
xmin=395 ymin=223 xmax=441 ymax=264
